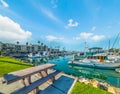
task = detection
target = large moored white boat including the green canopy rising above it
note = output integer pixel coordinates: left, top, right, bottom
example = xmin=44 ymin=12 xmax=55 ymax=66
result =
xmin=69 ymin=47 xmax=120 ymax=70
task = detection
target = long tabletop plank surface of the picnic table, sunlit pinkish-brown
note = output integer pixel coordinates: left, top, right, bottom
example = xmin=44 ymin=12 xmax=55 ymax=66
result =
xmin=4 ymin=64 xmax=55 ymax=84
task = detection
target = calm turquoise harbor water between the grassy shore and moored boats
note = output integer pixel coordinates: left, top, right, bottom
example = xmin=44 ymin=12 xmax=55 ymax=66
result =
xmin=23 ymin=56 xmax=120 ymax=88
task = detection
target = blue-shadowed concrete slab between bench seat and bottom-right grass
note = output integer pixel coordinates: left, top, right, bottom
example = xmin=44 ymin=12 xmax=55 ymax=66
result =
xmin=40 ymin=75 xmax=75 ymax=94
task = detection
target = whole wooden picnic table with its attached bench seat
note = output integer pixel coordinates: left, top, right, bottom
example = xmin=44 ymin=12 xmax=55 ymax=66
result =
xmin=4 ymin=64 xmax=59 ymax=94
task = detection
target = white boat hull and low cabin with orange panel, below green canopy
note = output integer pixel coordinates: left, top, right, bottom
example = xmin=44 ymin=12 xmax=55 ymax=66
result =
xmin=69 ymin=56 xmax=120 ymax=69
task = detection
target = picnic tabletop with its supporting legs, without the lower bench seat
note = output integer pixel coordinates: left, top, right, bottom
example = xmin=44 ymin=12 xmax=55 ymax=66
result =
xmin=4 ymin=64 xmax=55 ymax=86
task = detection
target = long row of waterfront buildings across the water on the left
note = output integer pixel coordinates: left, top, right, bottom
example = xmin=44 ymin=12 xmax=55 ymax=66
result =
xmin=0 ymin=42 xmax=65 ymax=56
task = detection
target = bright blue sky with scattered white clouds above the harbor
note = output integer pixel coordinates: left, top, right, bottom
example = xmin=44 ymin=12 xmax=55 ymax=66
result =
xmin=0 ymin=0 xmax=120 ymax=51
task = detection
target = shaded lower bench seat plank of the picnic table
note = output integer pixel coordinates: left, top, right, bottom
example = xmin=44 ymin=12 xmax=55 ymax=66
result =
xmin=12 ymin=71 xmax=60 ymax=94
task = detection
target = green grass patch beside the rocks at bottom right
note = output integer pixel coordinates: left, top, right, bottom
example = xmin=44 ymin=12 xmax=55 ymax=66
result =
xmin=71 ymin=82 xmax=112 ymax=94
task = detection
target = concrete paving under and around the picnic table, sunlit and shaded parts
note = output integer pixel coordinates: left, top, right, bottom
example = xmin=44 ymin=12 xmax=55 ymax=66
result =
xmin=0 ymin=70 xmax=75 ymax=94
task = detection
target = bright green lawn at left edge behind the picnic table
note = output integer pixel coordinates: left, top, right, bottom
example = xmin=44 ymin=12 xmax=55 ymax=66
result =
xmin=0 ymin=56 xmax=33 ymax=76
